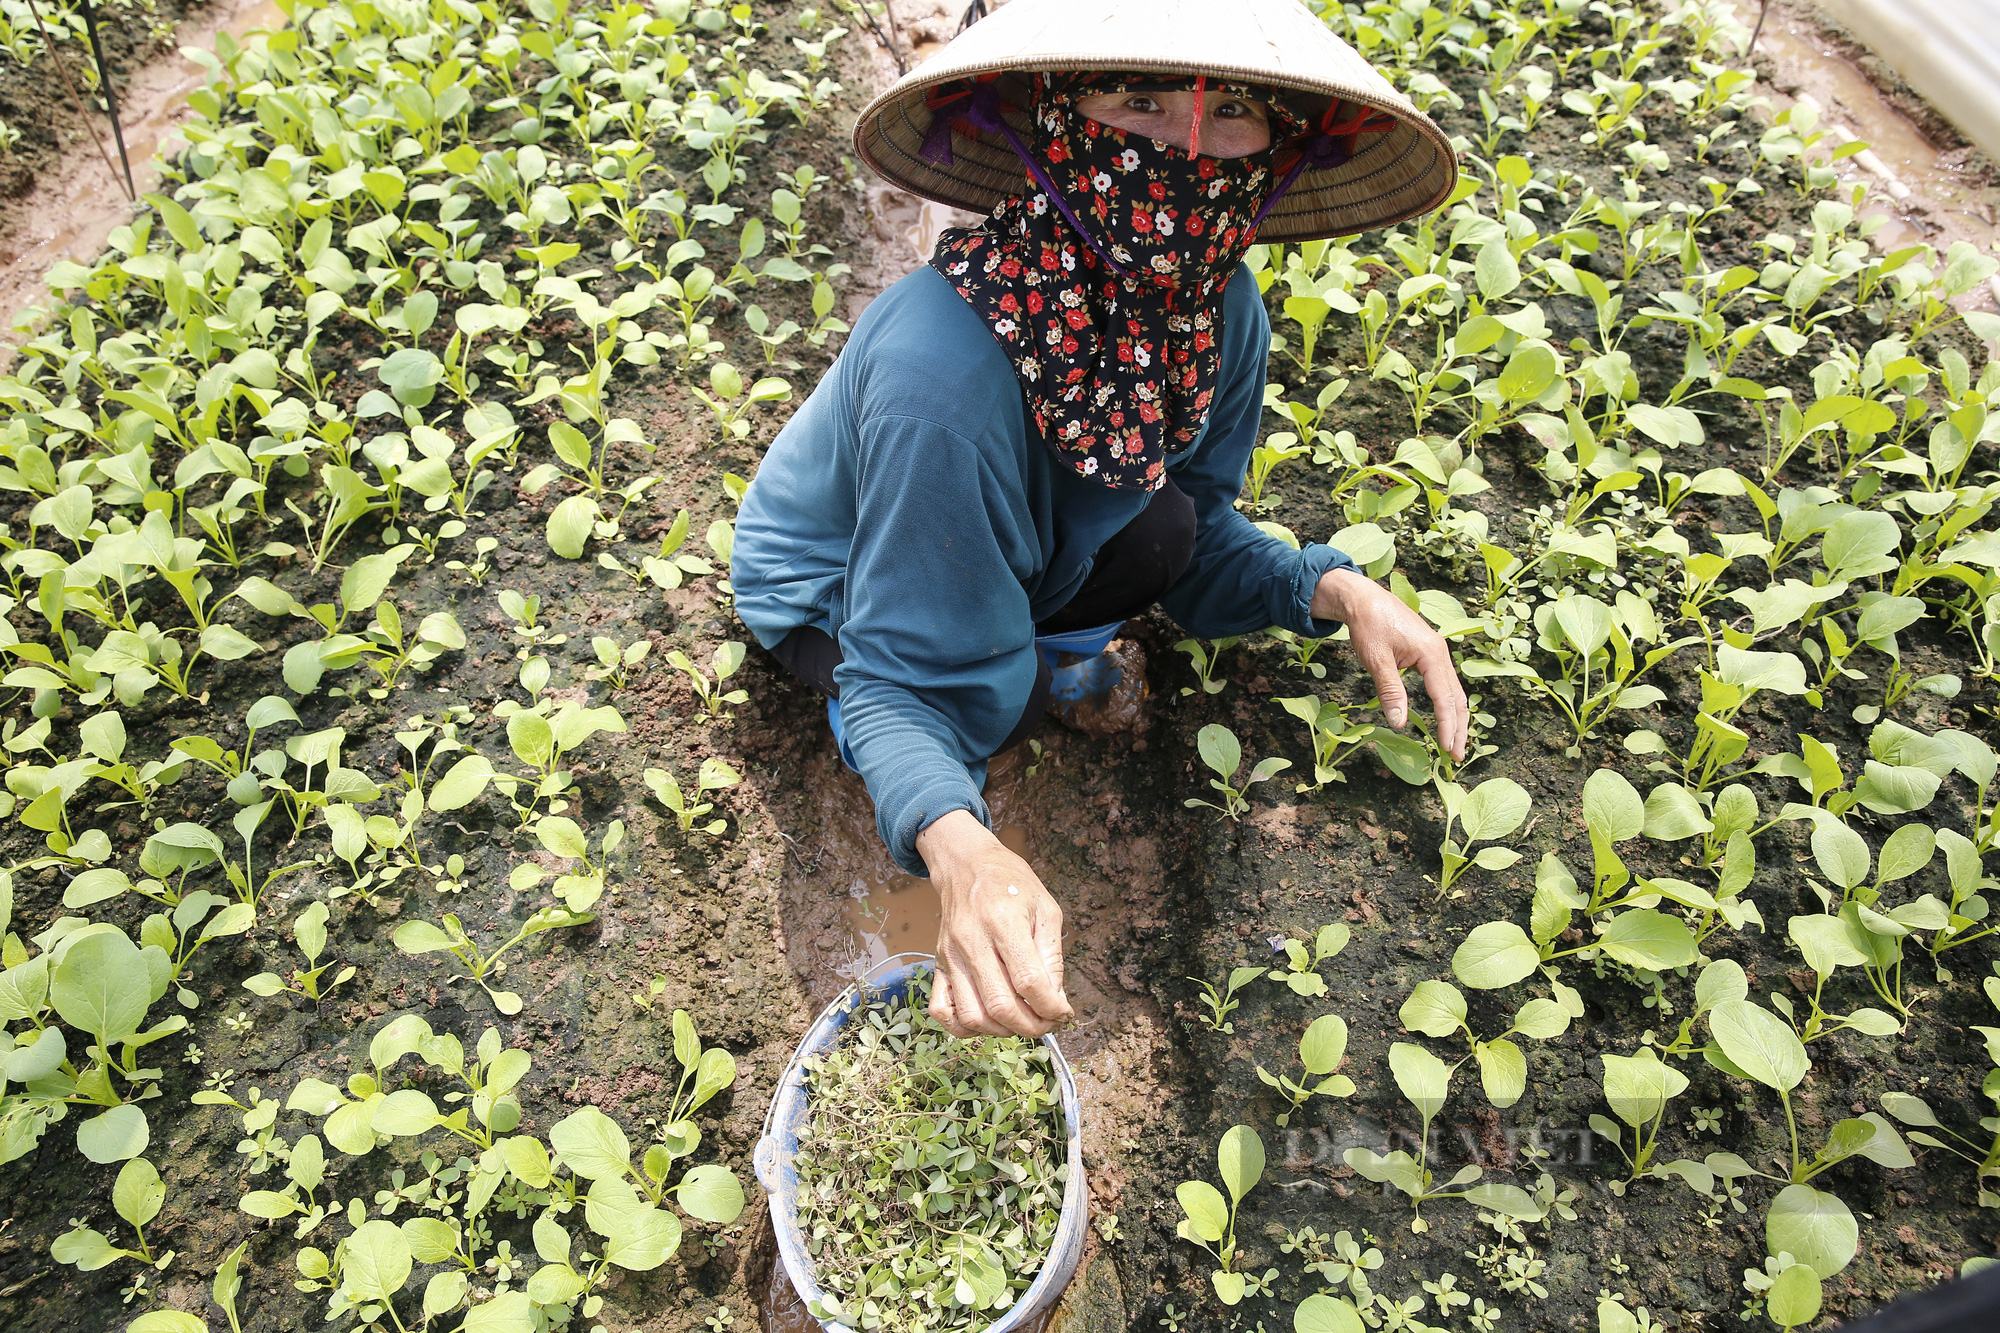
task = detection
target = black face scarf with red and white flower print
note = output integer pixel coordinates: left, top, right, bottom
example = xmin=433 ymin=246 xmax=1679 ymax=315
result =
xmin=930 ymin=74 xmax=1302 ymax=490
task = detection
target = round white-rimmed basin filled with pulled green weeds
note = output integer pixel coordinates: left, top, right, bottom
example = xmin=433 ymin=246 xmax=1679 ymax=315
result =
xmin=758 ymin=955 xmax=1088 ymax=1331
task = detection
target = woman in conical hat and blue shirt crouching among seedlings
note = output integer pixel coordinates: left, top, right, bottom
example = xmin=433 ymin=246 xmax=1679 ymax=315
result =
xmin=732 ymin=0 xmax=1466 ymax=1035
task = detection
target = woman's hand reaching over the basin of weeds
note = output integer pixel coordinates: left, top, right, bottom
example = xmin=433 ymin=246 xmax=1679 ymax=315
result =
xmin=916 ymin=811 xmax=1070 ymax=1037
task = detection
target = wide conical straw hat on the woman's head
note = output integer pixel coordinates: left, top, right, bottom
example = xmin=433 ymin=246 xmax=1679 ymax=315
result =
xmin=854 ymin=0 xmax=1458 ymax=240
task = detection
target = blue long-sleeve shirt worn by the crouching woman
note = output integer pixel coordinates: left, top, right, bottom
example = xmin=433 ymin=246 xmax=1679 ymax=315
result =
xmin=730 ymin=266 xmax=1352 ymax=875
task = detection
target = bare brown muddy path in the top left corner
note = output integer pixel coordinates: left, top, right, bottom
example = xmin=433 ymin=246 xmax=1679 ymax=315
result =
xmin=0 ymin=0 xmax=284 ymax=348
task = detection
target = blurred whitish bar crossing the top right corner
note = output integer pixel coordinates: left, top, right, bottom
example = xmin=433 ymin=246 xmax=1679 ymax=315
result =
xmin=1818 ymin=0 xmax=2000 ymax=158
